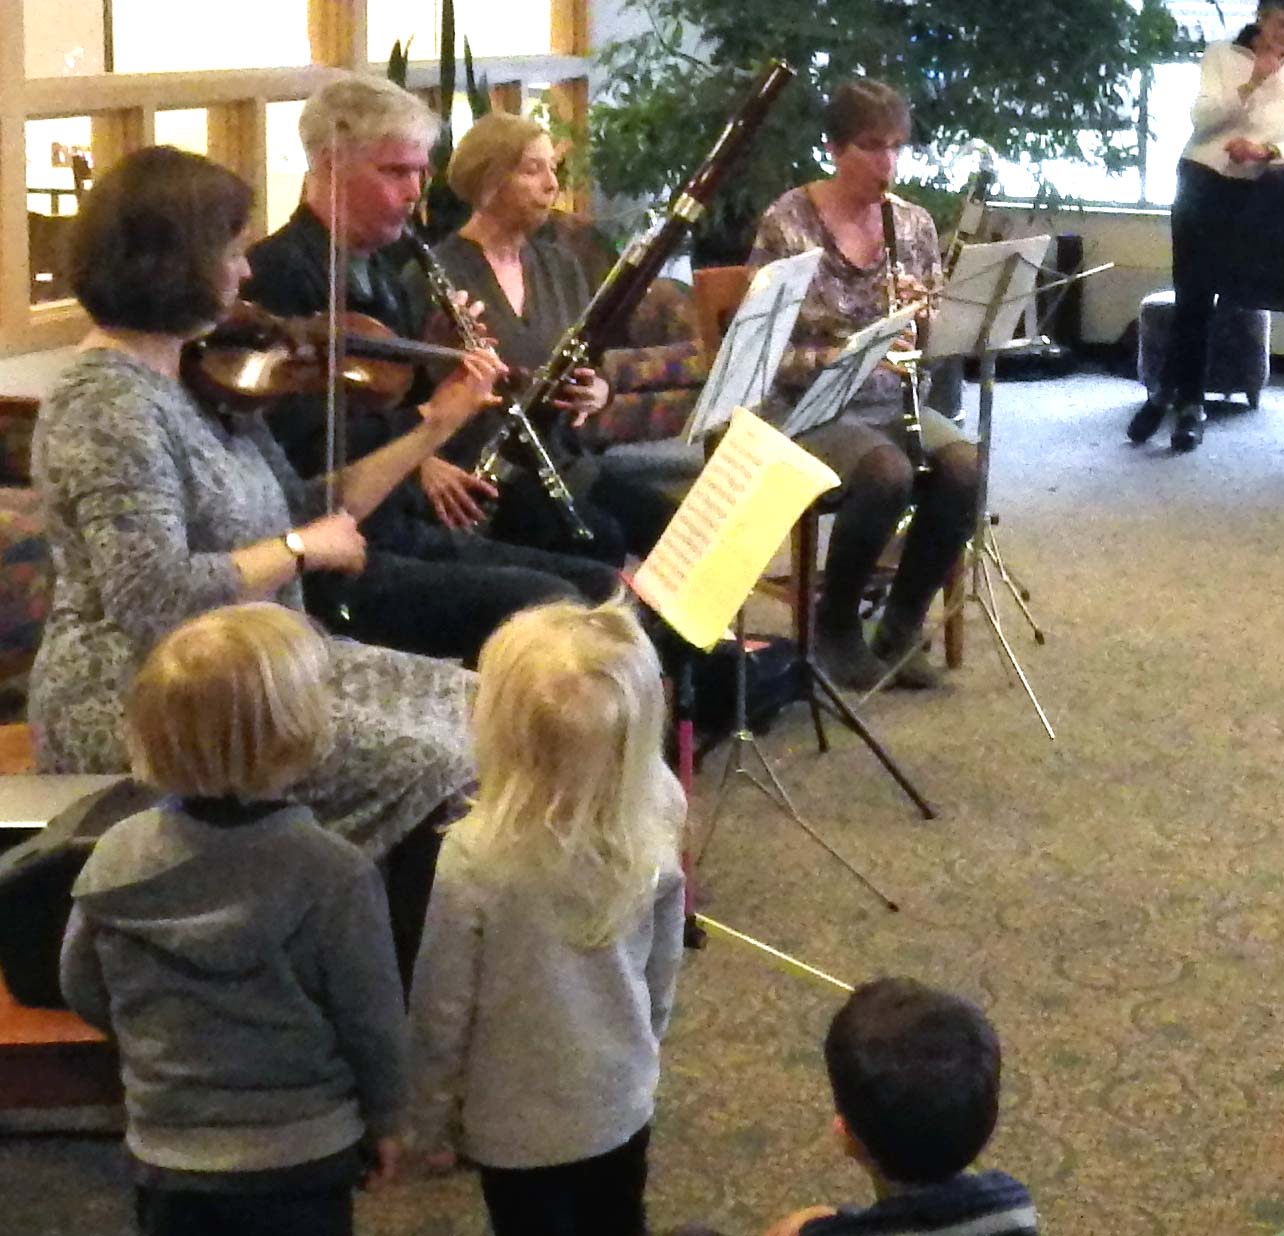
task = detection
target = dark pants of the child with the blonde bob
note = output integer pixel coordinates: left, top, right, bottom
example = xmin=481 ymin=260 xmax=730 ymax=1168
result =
xmin=134 ymin=1185 xmax=352 ymax=1236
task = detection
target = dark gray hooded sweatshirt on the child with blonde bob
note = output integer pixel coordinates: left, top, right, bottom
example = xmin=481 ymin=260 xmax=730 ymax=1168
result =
xmin=62 ymin=802 xmax=408 ymax=1172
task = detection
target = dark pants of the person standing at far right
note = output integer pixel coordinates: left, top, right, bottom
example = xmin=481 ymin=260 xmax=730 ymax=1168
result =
xmin=1161 ymin=159 xmax=1253 ymax=404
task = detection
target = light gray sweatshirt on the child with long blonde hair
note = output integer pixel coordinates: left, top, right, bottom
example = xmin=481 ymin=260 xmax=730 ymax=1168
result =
xmin=411 ymin=821 xmax=683 ymax=1168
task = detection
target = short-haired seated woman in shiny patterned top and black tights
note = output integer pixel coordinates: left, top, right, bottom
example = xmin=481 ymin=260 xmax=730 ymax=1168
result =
xmin=749 ymin=80 xmax=977 ymax=689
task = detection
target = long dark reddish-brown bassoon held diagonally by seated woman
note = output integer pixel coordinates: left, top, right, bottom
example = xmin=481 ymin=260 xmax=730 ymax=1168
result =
xmin=487 ymin=60 xmax=794 ymax=474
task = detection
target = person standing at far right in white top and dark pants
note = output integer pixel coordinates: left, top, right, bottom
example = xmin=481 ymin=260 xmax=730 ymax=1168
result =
xmin=1127 ymin=0 xmax=1284 ymax=451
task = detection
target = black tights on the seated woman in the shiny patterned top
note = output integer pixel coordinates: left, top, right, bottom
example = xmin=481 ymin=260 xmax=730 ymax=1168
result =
xmin=818 ymin=442 xmax=978 ymax=639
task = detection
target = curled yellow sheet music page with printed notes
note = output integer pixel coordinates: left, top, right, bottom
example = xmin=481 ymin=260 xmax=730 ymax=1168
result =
xmin=633 ymin=408 xmax=841 ymax=648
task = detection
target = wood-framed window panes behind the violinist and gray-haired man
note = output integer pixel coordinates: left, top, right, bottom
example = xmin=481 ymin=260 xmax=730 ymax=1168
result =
xmin=0 ymin=0 xmax=588 ymax=356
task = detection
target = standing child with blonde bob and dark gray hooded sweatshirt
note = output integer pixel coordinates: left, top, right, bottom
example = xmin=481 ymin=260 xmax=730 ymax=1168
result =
xmin=62 ymin=603 xmax=410 ymax=1236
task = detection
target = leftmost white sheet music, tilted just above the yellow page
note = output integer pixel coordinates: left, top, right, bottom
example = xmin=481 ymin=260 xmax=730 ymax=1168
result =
xmin=683 ymin=249 xmax=822 ymax=442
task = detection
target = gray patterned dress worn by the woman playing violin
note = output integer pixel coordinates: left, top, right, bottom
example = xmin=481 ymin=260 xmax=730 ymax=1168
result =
xmin=30 ymin=349 xmax=473 ymax=855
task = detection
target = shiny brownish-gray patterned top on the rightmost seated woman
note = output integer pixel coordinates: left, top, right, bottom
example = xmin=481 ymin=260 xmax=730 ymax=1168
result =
xmin=749 ymin=186 xmax=941 ymax=408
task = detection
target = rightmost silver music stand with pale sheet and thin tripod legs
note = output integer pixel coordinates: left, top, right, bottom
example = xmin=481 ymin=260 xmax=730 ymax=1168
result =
xmin=923 ymin=236 xmax=1057 ymax=739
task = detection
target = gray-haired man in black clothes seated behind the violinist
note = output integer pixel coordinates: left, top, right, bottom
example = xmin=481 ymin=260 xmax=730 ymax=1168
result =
xmin=244 ymin=73 xmax=618 ymax=662
